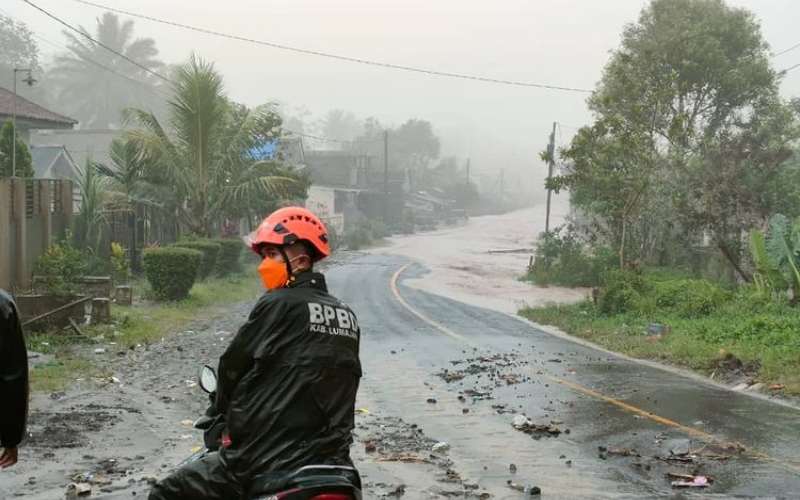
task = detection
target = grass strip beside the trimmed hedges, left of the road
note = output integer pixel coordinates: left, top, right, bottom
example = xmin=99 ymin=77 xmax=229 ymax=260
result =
xmin=26 ymin=275 xmax=260 ymax=392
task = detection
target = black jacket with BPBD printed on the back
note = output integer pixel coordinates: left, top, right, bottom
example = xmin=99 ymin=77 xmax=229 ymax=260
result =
xmin=216 ymin=272 xmax=361 ymax=481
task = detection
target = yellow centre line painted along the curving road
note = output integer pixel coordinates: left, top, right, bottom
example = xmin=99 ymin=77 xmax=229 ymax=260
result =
xmin=390 ymin=264 xmax=800 ymax=474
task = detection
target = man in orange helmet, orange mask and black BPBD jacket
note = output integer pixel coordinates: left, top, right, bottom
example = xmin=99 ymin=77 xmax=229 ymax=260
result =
xmin=149 ymin=207 xmax=361 ymax=500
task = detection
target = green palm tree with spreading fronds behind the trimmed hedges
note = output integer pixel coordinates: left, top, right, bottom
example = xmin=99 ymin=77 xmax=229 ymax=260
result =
xmin=127 ymin=56 xmax=298 ymax=236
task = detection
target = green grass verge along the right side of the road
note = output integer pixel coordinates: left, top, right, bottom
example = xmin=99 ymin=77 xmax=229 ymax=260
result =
xmin=520 ymin=294 xmax=800 ymax=395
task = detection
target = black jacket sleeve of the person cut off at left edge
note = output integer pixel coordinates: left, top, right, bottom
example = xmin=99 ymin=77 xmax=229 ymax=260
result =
xmin=0 ymin=290 xmax=28 ymax=448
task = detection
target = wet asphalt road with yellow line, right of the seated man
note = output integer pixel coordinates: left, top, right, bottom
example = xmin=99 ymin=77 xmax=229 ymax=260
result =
xmin=328 ymin=255 xmax=800 ymax=498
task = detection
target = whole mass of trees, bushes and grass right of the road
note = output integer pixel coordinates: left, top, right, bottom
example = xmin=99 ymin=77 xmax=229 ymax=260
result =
xmin=521 ymin=0 xmax=800 ymax=394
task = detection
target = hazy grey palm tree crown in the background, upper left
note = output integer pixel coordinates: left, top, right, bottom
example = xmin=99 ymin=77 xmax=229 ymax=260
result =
xmin=52 ymin=12 xmax=164 ymax=128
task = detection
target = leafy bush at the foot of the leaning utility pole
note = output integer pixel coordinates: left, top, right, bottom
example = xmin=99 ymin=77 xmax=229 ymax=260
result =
xmin=526 ymin=227 xmax=617 ymax=286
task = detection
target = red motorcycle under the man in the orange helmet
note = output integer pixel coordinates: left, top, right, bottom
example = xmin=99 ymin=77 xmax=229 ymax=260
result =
xmin=180 ymin=365 xmax=361 ymax=500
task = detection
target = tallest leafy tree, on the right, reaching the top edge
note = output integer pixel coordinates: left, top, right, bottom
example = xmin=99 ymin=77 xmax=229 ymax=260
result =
xmin=568 ymin=0 xmax=796 ymax=279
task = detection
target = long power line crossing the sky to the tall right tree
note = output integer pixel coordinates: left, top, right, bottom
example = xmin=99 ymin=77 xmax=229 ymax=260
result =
xmin=69 ymin=0 xmax=592 ymax=94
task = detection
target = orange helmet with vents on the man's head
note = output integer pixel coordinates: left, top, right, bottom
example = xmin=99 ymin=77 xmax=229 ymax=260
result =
xmin=245 ymin=207 xmax=331 ymax=262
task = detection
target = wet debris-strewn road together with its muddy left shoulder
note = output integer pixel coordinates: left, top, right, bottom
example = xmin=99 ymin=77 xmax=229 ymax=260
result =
xmin=0 ymin=255 xmax=800 ymax=499
